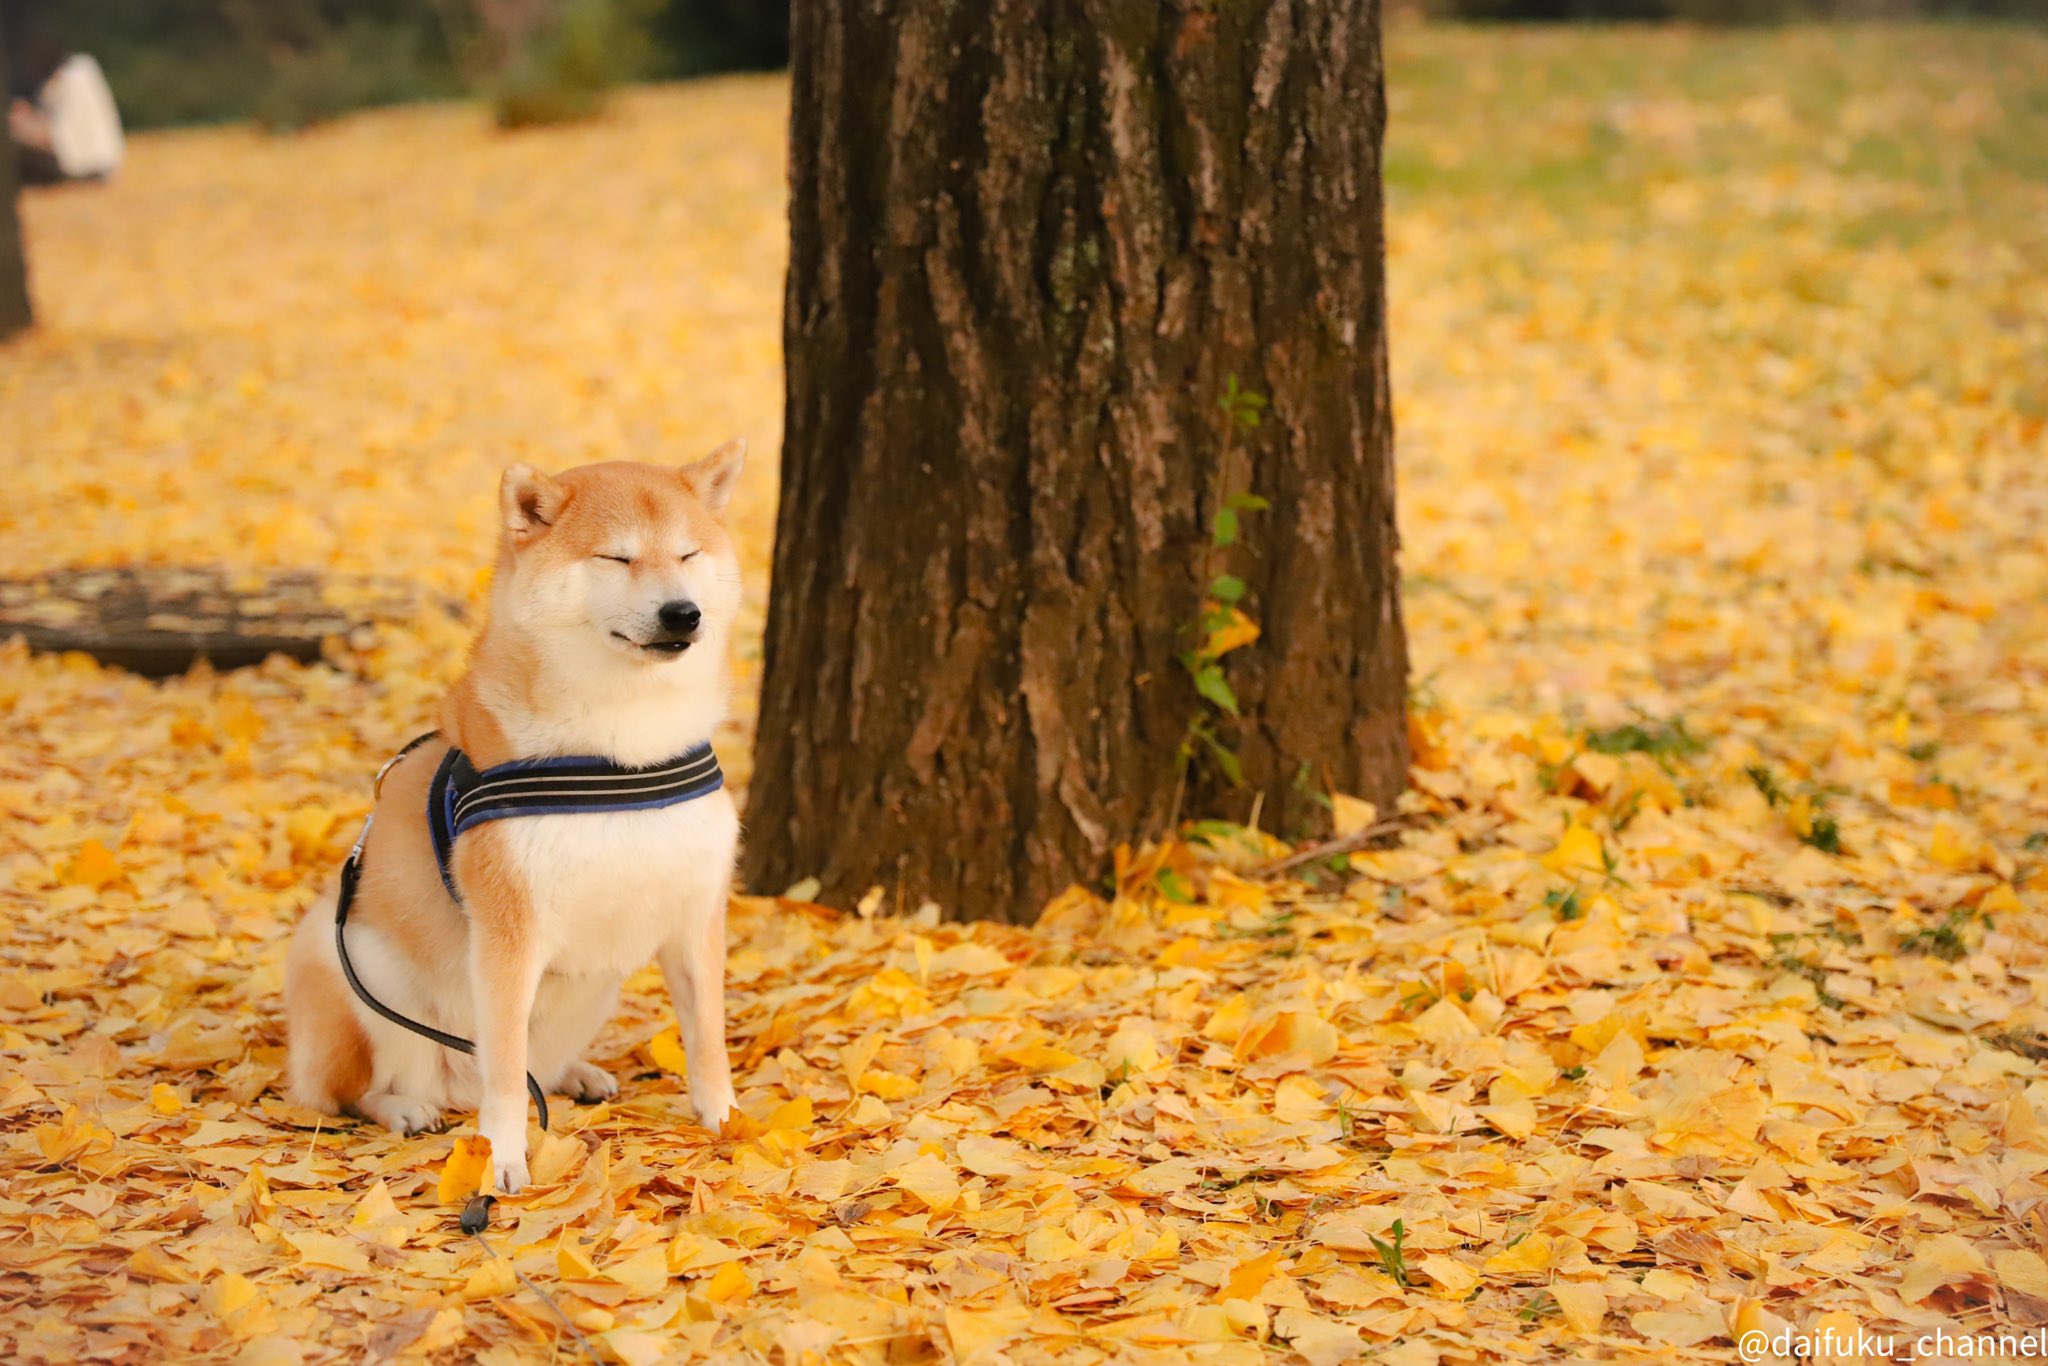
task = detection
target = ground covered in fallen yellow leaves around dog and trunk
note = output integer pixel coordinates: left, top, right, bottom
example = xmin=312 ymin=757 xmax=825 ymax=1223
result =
xmin=0 ymin=29 xmax=2048 ymax=1366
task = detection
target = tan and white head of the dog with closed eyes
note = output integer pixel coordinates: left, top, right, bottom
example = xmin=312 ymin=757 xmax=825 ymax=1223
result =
xmin=496 ymin=440 xmax=748 ymax=668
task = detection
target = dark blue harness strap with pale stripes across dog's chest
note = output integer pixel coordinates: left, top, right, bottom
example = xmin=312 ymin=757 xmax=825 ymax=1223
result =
xmin=426 ymin=743 xmax=725 ymax=901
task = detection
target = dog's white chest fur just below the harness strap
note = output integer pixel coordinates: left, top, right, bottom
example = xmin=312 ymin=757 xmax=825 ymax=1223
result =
xmin=504 ymin=791 xmax=739 ymax=975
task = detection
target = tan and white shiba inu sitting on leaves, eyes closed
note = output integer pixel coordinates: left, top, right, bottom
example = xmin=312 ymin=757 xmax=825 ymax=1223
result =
xmin=285 ymin=440 xmax=745 ymax=1194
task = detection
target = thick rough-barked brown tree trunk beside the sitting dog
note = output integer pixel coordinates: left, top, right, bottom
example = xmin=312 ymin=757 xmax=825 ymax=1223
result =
xmin=743 ymin=0 xmax=1407 ymax=920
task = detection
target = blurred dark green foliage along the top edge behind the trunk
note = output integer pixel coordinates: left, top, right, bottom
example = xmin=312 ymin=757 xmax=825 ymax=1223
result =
xmin=12 ymin=0 xmax=2048 ymax=129
